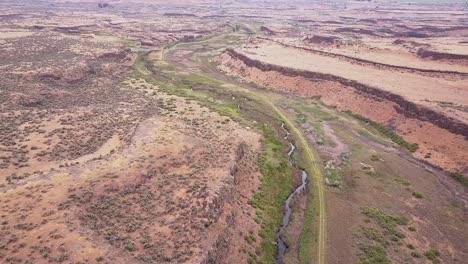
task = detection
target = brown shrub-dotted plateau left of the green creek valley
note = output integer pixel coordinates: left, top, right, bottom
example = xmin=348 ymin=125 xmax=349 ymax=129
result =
xmin=0 ymin=1 xmax=260 ymax=263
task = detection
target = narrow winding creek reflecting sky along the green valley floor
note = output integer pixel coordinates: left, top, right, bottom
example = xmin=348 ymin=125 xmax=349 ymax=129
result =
xmin=275 ymin=123 xmax=307 ymax=264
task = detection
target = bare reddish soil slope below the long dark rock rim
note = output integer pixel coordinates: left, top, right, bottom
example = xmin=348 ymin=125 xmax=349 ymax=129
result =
xmin=219 ymin=52 xmax=468 ymax=171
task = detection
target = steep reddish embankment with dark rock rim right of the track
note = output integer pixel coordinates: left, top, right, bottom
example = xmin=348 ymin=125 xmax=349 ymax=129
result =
xmin=219 ymin=49 xmax=468 ymax=171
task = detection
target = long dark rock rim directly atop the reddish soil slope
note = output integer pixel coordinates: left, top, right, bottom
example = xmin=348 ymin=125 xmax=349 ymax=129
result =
xmin=226 ymin=49 xmax=468 ymax=138
